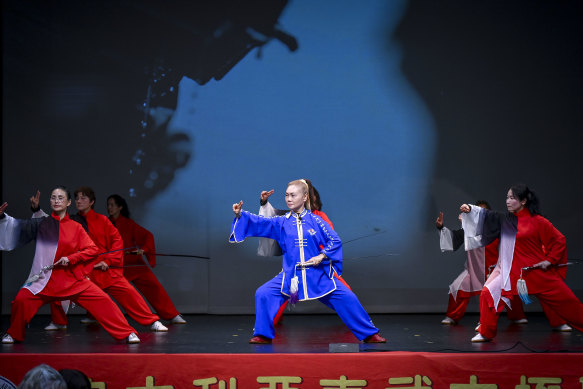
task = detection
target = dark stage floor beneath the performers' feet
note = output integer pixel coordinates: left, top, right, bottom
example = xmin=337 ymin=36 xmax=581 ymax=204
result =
xmin=0 ymin=314 xmax=583 ymax=354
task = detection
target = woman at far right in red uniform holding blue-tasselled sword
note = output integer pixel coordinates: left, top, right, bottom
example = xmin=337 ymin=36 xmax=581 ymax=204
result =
xmin=460 ymin=184 xmax=583 ymax=342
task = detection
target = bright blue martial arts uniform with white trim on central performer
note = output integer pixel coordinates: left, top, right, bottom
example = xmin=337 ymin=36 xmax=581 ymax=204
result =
xmin=229 ymin=210 xmax=379 ymax=340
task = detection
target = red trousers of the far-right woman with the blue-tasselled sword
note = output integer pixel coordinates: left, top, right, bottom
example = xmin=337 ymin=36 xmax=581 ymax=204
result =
xmin=479 ymin=277 xmax=583 ymax=339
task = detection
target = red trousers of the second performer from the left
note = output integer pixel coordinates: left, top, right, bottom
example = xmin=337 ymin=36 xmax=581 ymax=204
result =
xmin=51 ymin=277 xmax=160 ymax=326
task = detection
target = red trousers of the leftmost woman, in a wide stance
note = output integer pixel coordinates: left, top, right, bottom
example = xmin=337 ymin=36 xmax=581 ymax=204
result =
xmin=7 ymin=280 xmax=136 ymax=342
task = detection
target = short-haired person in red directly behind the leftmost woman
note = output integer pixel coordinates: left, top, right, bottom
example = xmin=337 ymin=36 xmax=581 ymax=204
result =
xmin=46 ymin=187 xmax=168 ymax=331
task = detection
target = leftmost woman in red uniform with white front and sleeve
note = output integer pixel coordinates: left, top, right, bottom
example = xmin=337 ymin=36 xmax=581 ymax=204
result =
xmin=0 ymin=187 xmax=140 ymax=343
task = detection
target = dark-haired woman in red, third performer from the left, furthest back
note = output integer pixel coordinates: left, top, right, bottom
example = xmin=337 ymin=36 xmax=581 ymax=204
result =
xmin=107 ymin=194 xmax=186 ymax=324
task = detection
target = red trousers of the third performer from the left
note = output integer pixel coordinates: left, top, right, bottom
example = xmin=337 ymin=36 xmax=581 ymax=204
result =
xmin=123 ymin=266 xmax=180 ymax=320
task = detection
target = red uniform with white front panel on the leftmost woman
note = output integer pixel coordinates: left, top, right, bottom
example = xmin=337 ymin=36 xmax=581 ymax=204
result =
xmin=7 ymin=214 xmax=136 ymax=341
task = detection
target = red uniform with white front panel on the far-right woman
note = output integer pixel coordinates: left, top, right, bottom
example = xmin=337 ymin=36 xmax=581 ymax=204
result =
xmin=472 ymin=207 xmax=583 ymax=338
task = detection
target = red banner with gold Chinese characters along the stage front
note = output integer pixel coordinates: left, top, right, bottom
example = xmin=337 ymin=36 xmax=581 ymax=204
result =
xmin=0 ymin=352 xmax=583 ymax=389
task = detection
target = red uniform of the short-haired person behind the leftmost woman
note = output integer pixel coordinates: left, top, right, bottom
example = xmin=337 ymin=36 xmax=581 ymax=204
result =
xmin=51 ymin=209 xmax=160 ymax=326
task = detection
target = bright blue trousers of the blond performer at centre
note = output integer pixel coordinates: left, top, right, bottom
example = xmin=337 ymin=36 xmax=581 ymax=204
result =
xmin=253 ymin=273 xmax=379 ymax=340
